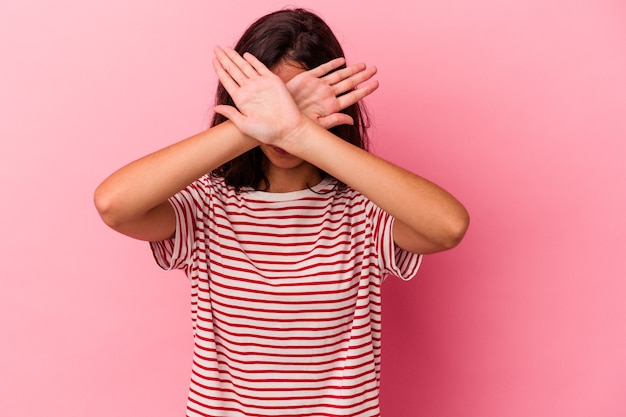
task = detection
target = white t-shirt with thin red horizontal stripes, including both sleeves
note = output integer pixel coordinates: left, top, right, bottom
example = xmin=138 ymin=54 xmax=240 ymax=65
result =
xmin=151 ymin=175 xmax=421 ymax=417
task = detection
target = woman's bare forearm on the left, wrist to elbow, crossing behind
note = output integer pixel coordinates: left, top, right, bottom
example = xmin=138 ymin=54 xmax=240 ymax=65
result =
xmin=94 ymin=122 xmax=258 ymax=225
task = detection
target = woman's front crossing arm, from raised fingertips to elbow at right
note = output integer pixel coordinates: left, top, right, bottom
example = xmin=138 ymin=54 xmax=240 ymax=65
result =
xmin=207 ymin=47 xmax=469 ymax=252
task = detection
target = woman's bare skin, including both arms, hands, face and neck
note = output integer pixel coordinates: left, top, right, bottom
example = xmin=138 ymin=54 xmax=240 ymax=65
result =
xmin=94 ymin=47 xmax=469 ymax=253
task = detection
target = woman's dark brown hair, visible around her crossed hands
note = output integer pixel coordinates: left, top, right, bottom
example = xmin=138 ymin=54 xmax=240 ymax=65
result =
xmin=211 ymin=8 xmax=368 ymax=189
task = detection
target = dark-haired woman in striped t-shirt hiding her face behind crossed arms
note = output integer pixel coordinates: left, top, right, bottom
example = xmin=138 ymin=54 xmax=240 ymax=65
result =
xmin=95 ymin=9 xmax=468 ymax=416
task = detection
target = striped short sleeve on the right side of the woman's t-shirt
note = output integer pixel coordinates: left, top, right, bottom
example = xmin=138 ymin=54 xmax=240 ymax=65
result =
xmin=367 ymin=201 xmax=422 ymax=281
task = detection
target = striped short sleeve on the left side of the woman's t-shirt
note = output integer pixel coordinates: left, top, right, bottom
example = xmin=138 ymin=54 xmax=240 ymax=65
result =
xmin=150 ymin=177 xmax=208 ymax=270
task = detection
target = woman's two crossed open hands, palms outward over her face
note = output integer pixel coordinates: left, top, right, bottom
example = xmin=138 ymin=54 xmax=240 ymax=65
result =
xmin=213 ymin=47 xmax=378 ymax=153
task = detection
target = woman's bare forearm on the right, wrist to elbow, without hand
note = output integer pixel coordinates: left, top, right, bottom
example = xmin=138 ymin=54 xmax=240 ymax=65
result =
xmin=287 ymin=118 xmax=469 ymax=252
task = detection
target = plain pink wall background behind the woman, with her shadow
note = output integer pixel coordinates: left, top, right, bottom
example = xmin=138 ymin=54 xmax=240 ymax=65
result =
xmin=0 ymin=0 xmax=626 ymax=417
